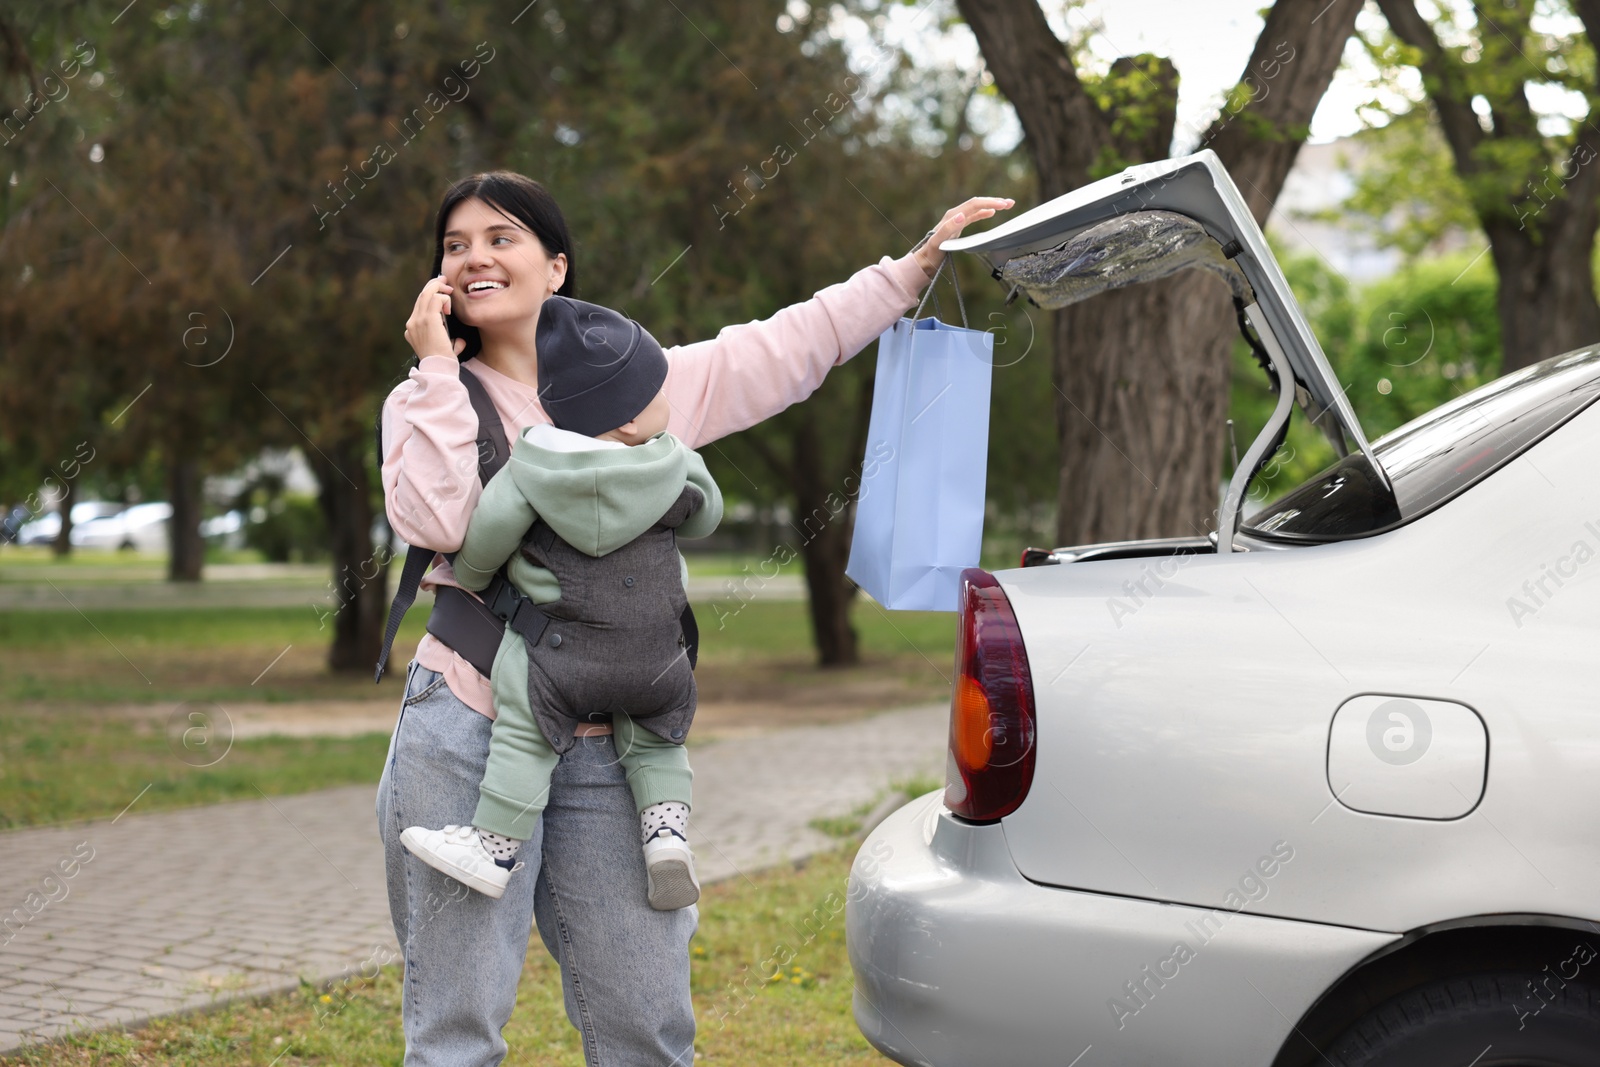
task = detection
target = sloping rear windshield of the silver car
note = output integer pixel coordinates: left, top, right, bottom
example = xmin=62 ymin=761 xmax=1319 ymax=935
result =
xmin=1245 ymin=346 xmax=1600 ymax=541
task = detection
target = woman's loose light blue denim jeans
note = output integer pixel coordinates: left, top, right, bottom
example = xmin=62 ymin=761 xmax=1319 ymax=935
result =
xmin=378 ymin=661 xmax=699 ymax=1067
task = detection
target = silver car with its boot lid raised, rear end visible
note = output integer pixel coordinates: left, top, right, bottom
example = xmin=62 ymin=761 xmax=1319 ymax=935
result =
xmin=848 ymin=152 xmax=1600 ymax=1067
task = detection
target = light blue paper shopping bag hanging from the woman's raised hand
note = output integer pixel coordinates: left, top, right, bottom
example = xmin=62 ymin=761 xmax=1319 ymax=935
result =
xmin=845 ymin=258 xmax=994 ymax=611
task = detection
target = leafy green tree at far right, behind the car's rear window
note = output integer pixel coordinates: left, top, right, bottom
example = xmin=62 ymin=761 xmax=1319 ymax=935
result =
xmin=1373 ymin=0 xmax=1600 ymax=371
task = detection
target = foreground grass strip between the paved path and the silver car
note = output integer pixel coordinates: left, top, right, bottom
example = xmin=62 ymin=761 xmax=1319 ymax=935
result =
xmin=0 ymin=848 xmax=888 ymax=1067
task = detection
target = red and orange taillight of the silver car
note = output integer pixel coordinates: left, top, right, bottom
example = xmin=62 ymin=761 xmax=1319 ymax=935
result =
xmin=944 ymin=566 xmax=1034 ymax=822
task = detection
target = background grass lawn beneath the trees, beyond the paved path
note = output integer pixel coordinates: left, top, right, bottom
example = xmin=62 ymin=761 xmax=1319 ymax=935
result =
xmin=0 ymin=572 xmax=955 ymax=829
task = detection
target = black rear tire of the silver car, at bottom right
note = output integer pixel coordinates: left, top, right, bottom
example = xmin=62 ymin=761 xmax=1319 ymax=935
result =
xmin=1328 ymin=968 xmax=1600 ymax=1067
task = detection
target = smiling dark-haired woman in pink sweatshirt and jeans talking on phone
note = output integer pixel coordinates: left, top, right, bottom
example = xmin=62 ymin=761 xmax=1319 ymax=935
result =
xmin=378 ymin=171 xmax=1013 ymax=1067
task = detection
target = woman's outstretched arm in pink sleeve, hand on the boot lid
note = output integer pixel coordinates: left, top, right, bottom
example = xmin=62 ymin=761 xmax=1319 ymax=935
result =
xmin=662 ymin=197 xmax=1014 ymax=448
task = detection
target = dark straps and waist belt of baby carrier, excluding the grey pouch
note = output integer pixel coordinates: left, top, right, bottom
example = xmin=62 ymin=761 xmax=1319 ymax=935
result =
xmin=373 ymin=363 xmax=699 ymax=681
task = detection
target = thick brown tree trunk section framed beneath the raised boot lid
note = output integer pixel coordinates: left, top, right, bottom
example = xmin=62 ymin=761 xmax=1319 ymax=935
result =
xmin=1054 ymin=272 xmax=1234 ymax=545
